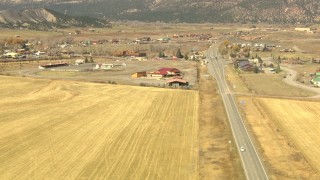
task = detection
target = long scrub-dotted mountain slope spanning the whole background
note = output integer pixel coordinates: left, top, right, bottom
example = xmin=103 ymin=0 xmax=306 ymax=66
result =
xmin=0 ymin=0 xmax=320 ymax=23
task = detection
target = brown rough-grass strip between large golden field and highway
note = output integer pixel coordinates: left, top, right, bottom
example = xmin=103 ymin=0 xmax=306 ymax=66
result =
xmin=199 ymin=69 xmax=245 ymax=180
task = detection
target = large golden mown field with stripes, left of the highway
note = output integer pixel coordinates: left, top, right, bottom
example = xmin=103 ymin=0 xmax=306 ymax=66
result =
xmin=0 ymin=76 xmax=199 ymax=180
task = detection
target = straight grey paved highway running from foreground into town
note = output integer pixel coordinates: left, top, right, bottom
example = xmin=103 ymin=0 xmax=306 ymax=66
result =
xmin=206 ymin=45 xmax=268 ymax=180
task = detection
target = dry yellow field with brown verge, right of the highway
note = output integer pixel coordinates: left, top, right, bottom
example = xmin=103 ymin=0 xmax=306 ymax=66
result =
xmin=238 ymin=97 xmax=320 ymax=179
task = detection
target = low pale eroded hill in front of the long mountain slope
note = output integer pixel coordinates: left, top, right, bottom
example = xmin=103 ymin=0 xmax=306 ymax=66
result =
xmin=0 ymin=8 xmax=109 ymax=30
